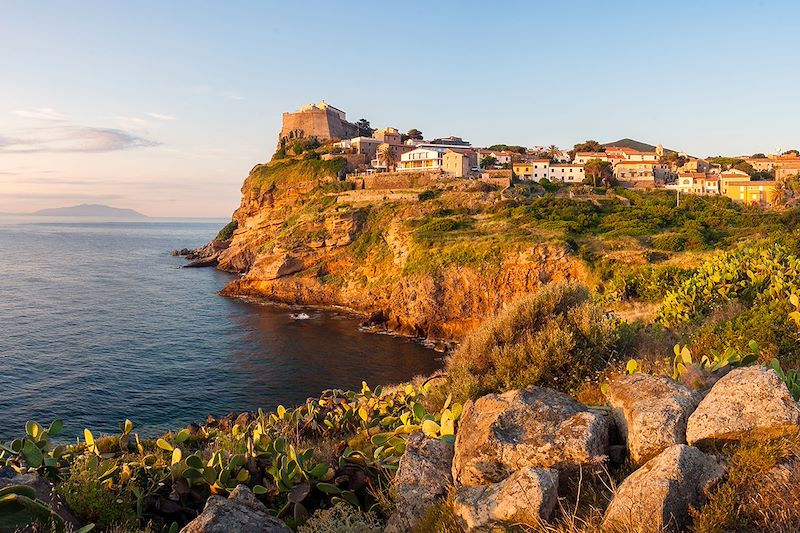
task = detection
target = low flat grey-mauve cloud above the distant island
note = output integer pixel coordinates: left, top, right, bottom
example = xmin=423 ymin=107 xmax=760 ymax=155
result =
xmin=0 ymin=125 xmax=160 ymax=153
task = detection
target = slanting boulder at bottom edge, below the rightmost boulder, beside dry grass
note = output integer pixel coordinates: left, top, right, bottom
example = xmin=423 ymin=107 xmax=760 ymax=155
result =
xmin=603 ymin=444 xmax=725 ymax=533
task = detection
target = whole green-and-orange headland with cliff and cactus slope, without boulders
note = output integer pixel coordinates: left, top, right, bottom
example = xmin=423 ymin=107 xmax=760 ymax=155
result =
xmin=0 ymin=159 xmax=800 ymax=533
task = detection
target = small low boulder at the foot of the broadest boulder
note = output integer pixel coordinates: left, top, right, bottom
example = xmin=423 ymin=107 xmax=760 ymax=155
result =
xmin=453 ymin=467 xmax=558 ymax=532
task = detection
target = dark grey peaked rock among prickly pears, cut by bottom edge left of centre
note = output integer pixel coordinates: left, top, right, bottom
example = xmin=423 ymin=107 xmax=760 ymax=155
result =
xmin=181 ymin=485 xmax=292 ymax=533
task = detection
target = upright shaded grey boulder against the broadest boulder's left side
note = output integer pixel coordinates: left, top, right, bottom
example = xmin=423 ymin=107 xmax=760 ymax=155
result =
xmin=384 ymin=433 xmax=453 ymax=533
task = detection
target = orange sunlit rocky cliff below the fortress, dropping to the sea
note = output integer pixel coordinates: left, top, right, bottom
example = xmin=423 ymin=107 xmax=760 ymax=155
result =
xmin=209 ymin=161 xmax=585 ymax=340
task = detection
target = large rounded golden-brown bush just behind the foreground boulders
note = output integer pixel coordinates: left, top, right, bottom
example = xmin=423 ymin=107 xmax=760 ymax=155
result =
xmin=447 ymin=283 xmax=619 ymax=399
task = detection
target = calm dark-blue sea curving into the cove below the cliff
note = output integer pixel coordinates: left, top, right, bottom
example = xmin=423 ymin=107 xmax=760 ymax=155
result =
xmin=0 ymin=217 xmax=442 ymax=440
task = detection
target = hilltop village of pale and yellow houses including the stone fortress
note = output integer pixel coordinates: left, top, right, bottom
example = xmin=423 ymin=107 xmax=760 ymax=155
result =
xmin=276 ymin=101 xmax=800 ymax=206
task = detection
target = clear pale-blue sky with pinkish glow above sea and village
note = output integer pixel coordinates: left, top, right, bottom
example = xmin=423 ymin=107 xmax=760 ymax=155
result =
xmin=0 ymin=0 xmax=800 ymax=217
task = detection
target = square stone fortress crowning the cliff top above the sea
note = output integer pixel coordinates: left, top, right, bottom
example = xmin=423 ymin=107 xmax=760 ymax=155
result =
xmin=278 ymin=100 xmax=359 ymax=145
